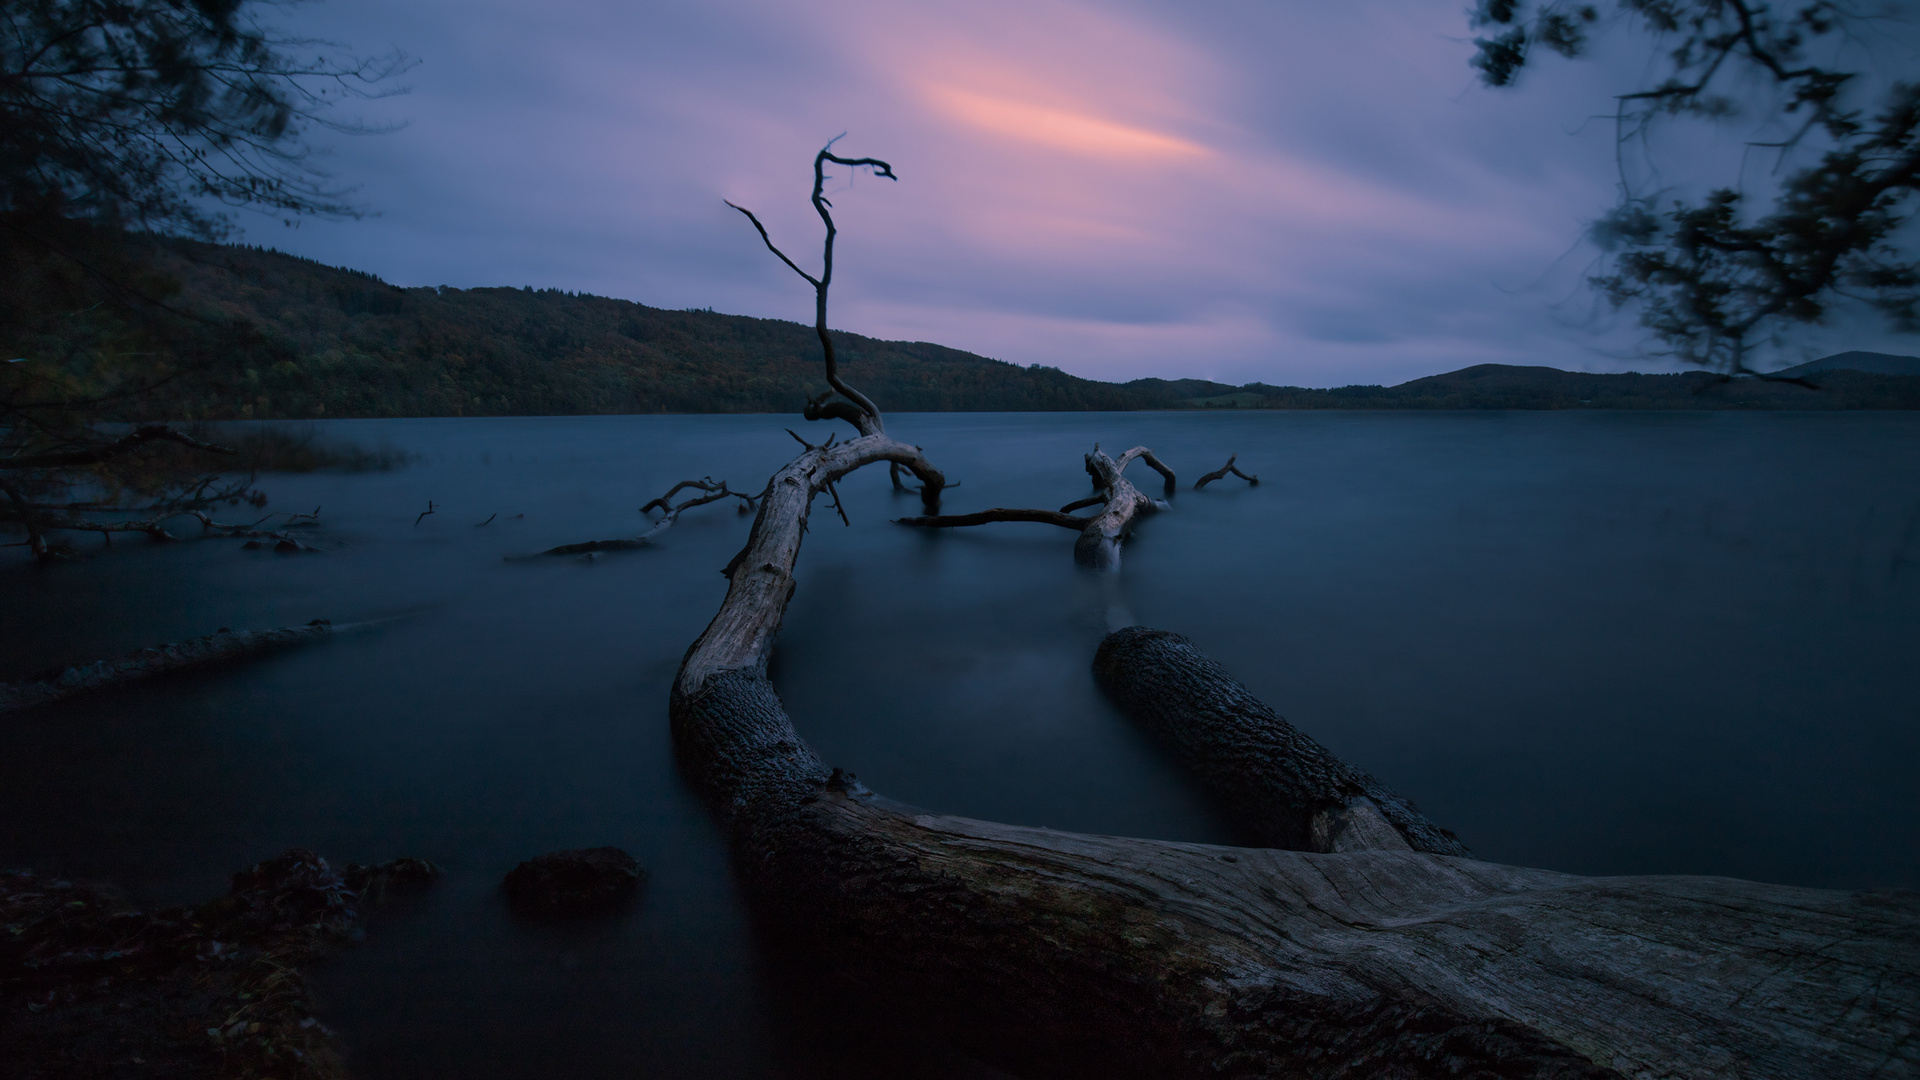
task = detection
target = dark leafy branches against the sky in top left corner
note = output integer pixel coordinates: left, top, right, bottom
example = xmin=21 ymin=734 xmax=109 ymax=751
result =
xmin=0 ymin=0 xmax=407 ymax=236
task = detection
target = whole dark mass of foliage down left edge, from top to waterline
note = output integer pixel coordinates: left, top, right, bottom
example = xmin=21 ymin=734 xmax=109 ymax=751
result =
xmin=0 ymin=0 xmax=407 ymax=557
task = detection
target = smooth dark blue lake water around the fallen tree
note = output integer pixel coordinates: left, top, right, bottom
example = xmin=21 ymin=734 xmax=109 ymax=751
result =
xmin=0 ymin=413 xmax=1920 ymax=1078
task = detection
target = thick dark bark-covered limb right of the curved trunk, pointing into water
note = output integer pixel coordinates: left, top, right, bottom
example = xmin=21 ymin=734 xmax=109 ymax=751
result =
xmin=1092 ymin=626 xmax=1469 ymax=855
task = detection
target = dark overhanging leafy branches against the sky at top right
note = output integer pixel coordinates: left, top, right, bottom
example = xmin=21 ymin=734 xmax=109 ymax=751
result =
xmin=1473 ymin=0 xmax=1920 ymax=375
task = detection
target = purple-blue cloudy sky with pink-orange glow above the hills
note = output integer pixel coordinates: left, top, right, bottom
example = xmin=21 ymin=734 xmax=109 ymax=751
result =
xmin=263 ymin=0 xmax=1920 ymax=386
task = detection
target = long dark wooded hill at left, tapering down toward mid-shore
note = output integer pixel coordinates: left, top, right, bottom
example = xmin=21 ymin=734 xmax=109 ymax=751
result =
xmin=161 ymin=244 xmax=1167 ymax=417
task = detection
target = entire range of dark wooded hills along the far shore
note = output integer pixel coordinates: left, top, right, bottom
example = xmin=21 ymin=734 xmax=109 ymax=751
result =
xmin=142 ymin=242 xmax=1920 ymax=419
